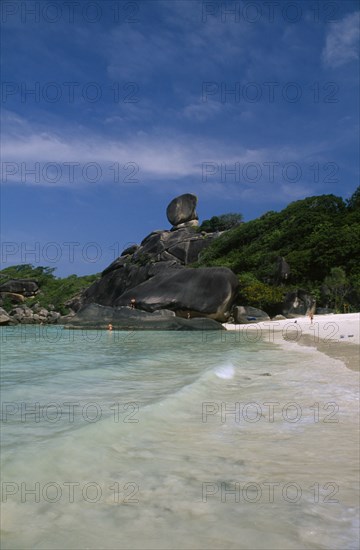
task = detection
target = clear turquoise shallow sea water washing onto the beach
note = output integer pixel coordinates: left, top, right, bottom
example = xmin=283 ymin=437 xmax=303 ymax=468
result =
xmin=0 ymin=326 xmax=359 ymax=549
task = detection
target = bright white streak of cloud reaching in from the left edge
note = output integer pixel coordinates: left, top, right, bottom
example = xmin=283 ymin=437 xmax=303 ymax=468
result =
xmin=2 ymin=126 xmax=266 ymax=184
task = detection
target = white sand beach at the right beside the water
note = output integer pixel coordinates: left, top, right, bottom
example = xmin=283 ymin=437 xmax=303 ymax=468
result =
xmin=223 ymin=313 xmax=360 ymax=372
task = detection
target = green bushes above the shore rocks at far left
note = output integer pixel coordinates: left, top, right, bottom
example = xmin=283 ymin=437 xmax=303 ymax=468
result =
xmin=0 ymin=264 xmax=99 ymax=315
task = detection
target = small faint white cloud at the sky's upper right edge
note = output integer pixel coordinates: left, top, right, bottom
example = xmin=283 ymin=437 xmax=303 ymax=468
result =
xmin=322 ymin=11 xmax=360 ymax=68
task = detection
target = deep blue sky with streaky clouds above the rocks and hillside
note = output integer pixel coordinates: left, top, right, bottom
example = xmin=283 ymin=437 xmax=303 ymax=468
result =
xmin=1 ymin=0 xmax=359 ymax=276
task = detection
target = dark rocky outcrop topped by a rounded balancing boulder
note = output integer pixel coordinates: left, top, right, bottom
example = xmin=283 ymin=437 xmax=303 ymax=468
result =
xmin=66 ymin=194 xmax=233 ymax=321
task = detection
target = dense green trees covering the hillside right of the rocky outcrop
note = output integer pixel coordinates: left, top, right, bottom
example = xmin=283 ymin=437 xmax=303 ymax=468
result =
xmin=195 ymin=187 xmax=360 ymax=311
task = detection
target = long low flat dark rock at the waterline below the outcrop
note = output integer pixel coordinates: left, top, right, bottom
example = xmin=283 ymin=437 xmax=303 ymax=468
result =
xmin=61 ymin=304 xmax=224 ymax=330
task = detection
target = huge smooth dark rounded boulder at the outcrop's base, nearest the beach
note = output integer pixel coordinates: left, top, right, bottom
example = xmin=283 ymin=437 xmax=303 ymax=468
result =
xmin=115 ymin=267 xmax=239 ymax=322
